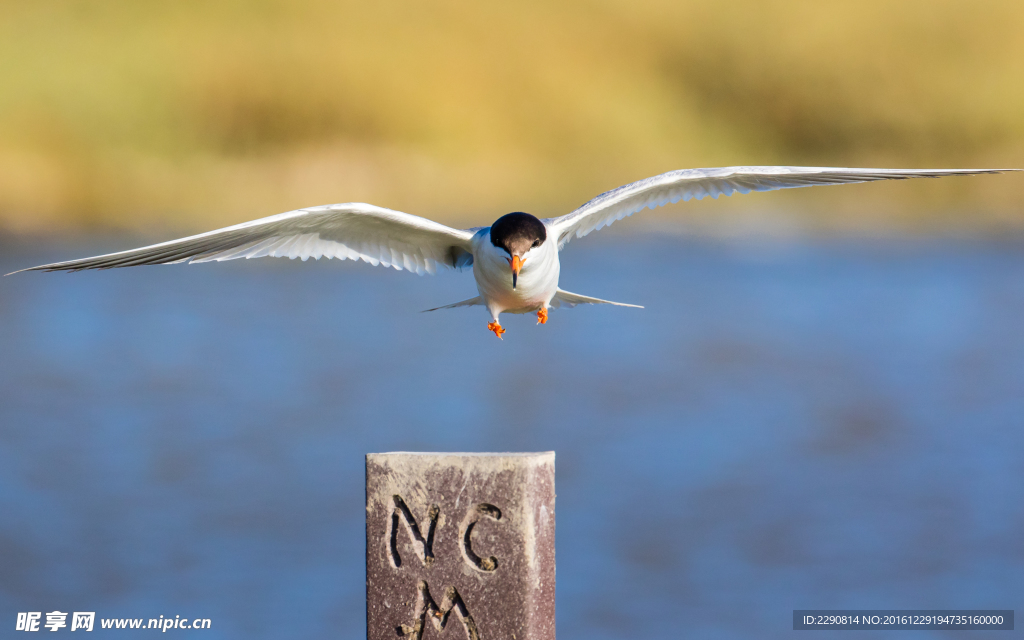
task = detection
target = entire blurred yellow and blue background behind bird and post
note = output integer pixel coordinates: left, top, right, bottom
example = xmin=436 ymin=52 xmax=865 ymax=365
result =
xmin=0 ymin=0 xmax=1024 ymax=638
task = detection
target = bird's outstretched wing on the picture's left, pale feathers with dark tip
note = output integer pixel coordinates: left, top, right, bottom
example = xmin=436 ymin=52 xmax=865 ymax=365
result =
xmin=15 ymin=203 xmax=473 ymax=274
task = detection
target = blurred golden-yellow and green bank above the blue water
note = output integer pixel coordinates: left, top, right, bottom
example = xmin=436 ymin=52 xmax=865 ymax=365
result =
xmin=0 ymin=0 xmax=1024 ymax=231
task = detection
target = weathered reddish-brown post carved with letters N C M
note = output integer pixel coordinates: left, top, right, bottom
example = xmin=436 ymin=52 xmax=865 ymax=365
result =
xmin=367 ymin=452 xmax=555 ymax=640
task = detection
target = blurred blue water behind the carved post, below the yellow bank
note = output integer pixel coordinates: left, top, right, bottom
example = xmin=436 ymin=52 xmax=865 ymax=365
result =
xmin=0 ymin=233 xmax=1024 ymax=639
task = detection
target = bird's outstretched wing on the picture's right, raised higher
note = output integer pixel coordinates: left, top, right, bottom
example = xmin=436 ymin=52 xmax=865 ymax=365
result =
xmin=544 ymin=167 xmax=1019 ymax=248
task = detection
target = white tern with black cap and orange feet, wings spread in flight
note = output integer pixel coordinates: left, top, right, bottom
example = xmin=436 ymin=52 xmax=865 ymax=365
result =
xmin=15 ymin=167 xmax=1019 ymax=338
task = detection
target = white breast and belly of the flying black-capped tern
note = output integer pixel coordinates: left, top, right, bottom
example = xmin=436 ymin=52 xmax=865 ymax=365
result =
xmin=473 ymin=229 xmax=559 ymax=314
